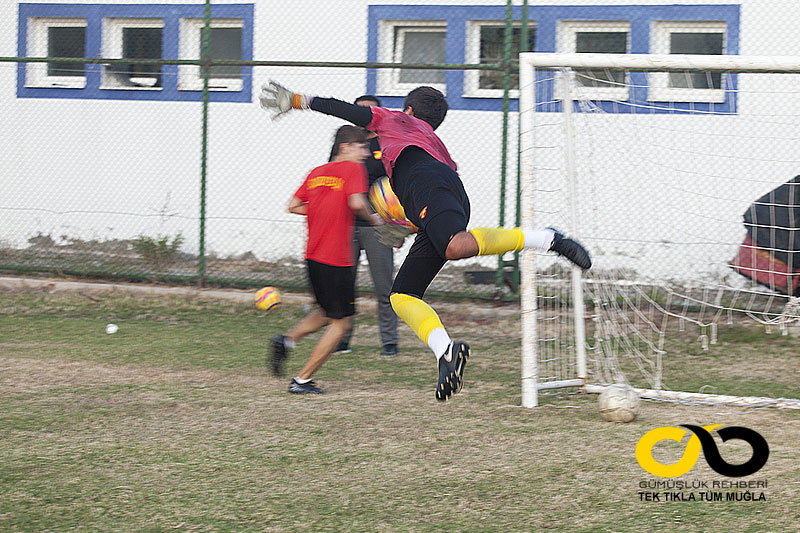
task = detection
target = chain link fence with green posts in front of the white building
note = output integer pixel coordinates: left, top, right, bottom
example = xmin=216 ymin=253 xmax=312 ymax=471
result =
xmin=0 ymin=0 xmax=800 ymax=297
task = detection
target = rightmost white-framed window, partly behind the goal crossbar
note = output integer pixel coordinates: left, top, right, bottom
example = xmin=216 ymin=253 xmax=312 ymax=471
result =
xmin=648 ymin=21 xmax=726 ymax=102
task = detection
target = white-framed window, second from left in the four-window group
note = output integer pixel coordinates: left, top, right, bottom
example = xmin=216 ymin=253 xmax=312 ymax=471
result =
xmin=464 ymin=21 xmax=536 ymax=98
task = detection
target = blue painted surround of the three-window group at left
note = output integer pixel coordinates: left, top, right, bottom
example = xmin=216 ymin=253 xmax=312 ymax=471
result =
xmin=17 ymin=4 xmax=254 ymax=103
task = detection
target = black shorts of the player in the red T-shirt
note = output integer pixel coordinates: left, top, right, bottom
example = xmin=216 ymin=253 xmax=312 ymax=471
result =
xmin=306 ymin=259 xmax=356 ymax=318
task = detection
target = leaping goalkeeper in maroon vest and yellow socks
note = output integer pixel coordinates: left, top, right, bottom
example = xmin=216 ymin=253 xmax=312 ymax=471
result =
xmin=260 ymin=81 xmax=592 ymax=400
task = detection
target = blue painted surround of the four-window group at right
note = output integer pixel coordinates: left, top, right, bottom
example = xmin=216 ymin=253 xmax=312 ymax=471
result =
xmin=366 ymin=4 xmax=740 ymax=113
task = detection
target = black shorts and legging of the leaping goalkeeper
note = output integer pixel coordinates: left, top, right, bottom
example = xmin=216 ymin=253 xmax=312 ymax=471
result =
xmin=392 ymin=146 xmax=470 ymax=298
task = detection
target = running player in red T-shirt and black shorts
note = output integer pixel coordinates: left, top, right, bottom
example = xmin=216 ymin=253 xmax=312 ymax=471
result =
xmin=272 ymin=122 xmax=381 ymax=394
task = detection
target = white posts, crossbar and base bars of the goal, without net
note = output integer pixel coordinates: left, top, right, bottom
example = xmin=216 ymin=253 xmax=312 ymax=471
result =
xmin=519 ymin=53 xmax=800 ymax=409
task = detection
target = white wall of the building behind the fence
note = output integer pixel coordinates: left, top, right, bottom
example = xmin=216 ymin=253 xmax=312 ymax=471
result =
xmin=0 ymin=0 xmax=800 ymax=275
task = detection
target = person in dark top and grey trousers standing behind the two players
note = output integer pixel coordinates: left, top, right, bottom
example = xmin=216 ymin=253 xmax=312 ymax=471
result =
xmin=336 ymin=95 xmax=397 ymax=357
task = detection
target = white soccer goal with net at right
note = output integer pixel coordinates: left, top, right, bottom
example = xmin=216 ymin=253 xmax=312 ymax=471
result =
xmin=520 ymin=53 xmax=800 ymax=408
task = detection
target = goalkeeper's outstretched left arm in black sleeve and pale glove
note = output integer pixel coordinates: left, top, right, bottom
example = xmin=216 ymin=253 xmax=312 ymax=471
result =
xmin=259 ymin=81 xmax=372 ymax=128
